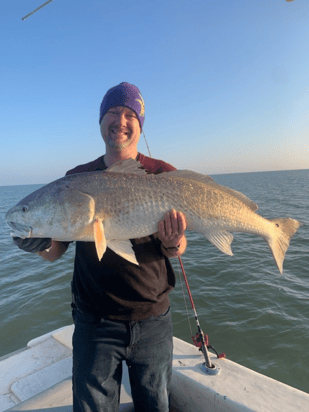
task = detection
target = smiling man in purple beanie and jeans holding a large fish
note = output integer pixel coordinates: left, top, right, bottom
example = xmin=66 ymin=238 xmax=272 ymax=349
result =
xmin=14 ymin=83 xmax=186 ymax=412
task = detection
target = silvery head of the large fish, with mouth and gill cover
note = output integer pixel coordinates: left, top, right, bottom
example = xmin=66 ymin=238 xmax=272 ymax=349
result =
xmin=5 ymin=178 xmax=94 ymax=241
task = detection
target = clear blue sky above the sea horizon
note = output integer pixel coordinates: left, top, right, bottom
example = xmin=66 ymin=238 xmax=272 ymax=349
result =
xmin=0 ymin=0 xmax=309 ymax=185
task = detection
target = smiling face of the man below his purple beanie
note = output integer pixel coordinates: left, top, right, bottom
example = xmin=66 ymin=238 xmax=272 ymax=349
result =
xmin=101 ymin=106 xmax=141 ymax=151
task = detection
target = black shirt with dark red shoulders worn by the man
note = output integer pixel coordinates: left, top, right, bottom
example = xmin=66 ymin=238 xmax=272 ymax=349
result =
xmin=66 ymin=153 xmax=176 ymax=321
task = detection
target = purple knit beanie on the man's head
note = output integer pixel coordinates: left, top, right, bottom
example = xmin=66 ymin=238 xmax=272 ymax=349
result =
xmin=99 ymin=82 xmax=145 ymax=130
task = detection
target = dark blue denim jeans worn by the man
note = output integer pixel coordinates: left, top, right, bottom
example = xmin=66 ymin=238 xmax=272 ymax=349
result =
xmin=73 ymin=309 xmax=173 ymax=412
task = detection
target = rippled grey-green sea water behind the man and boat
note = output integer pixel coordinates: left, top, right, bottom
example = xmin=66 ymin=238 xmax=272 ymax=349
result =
xmin=0 ymin=170 xmax=309 ymax=392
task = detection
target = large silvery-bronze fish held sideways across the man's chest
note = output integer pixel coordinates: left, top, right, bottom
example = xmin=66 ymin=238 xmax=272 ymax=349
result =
xmin=6 ymin=159 xmax=300 ymax=273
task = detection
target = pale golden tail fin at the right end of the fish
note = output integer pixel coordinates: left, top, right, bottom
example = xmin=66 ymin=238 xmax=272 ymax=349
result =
xmin=266 ymin=218 xmax=301 ymax=274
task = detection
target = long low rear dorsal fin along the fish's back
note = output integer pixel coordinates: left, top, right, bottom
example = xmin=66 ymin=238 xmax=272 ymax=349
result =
xmin=156 ymin=170 xmax=258 ymax=211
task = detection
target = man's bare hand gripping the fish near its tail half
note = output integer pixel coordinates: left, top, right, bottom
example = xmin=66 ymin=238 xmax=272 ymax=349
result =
xmin=158 ymin=209 xmax=187 ymax=257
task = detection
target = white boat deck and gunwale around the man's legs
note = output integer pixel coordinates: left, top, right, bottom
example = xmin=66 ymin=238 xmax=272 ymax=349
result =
xmin=0 ymin=325 xmax=309 ymax=412
